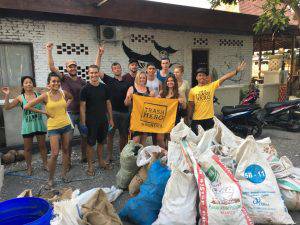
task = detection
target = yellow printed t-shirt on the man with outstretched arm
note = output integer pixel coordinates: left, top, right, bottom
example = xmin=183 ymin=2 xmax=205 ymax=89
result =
xmin=189 ymin=80 xmax=220 ymax=120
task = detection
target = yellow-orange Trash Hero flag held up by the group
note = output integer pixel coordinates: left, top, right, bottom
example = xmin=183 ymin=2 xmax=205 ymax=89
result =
xmin=130 ymin=94 xmax=178 ymax=133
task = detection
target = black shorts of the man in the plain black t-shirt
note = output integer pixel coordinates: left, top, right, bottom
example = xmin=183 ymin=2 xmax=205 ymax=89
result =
xmin=86 ymin=122 xmax=108 ymax=146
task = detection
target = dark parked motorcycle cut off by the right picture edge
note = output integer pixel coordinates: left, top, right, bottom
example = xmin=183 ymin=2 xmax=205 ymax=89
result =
xmin=257 ymin=99 xmax=300 ymax=132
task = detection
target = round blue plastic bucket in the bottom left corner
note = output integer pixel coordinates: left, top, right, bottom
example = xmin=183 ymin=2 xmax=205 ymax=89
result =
xmin=0 ymin=197 xmax=53 ymax=225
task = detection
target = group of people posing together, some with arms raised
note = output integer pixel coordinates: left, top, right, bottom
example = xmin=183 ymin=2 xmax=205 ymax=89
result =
xmin=2 ymin=43 xmax=245 ymax=188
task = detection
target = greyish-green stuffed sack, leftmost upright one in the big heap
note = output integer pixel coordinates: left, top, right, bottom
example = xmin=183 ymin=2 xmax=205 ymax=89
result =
xmin=116 ymin=141 xmax=143 ymax=189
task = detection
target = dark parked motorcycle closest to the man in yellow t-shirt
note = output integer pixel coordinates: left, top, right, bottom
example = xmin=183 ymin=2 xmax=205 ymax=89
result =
xmin=214 ymin=97 xmax=262 ymax=138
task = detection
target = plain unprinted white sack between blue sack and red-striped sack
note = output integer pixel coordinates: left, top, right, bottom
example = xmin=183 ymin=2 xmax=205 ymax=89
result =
xmin=152 ymin=167 xmax=197 ymax=225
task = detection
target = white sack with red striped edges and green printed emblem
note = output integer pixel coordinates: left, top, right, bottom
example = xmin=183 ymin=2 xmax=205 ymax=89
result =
xmin=181 ymin=140 xmax=253 ymax=225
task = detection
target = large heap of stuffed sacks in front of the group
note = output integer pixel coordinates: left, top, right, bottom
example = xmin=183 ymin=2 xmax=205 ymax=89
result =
xmin=117 ymin=118 xmax=300 ymax=225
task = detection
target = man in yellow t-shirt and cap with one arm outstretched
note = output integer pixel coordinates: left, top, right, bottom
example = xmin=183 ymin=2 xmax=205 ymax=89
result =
xmin=189 ymin=61 xmax=245 ymax=134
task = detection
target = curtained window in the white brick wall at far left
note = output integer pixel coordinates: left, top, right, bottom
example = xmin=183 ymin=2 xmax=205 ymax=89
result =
xmin=0 ymin=43 xmax=34 ymax=87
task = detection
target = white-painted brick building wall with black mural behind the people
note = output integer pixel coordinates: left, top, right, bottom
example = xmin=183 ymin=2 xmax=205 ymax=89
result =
xmin=0 ymin=0 xmax=253 ymax=146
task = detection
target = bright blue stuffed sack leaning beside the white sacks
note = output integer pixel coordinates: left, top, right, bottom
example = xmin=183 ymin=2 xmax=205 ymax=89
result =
xmin=119 ymin=160 xmax=170 ymax=225
